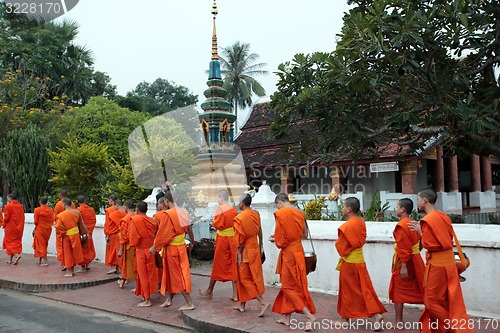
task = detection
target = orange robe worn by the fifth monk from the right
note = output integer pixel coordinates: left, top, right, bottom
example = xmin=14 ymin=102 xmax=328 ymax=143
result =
xmin=233 ymin=208 xmax=265 ymax=302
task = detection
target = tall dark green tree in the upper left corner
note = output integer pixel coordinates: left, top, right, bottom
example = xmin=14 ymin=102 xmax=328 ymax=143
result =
xmin=0 ymin=7 xmax=116 ymax=105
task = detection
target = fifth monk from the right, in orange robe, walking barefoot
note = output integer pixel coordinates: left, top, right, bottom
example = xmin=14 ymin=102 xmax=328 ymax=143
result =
xmin=233 ymin=194 xmax=270 ymax=317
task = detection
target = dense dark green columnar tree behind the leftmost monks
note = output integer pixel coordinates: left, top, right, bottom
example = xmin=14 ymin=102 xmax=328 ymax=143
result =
xmin=0 ymin=124 xmax=51 ymax=212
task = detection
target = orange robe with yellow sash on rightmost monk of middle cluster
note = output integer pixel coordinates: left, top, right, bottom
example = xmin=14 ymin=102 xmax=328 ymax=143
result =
xmin=154 ymin=208 xmax=193 ymax=295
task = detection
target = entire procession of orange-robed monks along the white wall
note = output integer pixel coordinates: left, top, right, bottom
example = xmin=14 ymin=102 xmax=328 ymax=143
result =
xmin=0 ymin=185 xmax=473 ymax=333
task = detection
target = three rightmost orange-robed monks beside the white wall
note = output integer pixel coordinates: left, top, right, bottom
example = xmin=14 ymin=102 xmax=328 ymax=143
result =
xmin=335 ymin=189 xmax=474 ymax=333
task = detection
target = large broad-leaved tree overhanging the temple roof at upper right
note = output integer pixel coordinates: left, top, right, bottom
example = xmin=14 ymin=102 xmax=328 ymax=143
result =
xmin=271 ymin=0 xmax=500 ymax=159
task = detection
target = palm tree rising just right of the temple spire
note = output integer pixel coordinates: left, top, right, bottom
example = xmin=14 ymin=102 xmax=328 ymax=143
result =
xmin=220 ymin=42 xmax=268 ymax=133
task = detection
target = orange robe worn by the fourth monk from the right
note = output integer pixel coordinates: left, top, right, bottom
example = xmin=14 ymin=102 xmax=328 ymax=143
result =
xmin=273 ymin=207 xmax=316 ymax=315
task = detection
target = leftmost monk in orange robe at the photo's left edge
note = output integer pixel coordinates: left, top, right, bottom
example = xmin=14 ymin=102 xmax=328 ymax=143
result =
xmin=2 ymin=193 xmax=24 ymax=265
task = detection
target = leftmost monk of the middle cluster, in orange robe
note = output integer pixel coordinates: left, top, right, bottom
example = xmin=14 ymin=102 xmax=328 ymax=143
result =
xmin=104 ymin=195 xmax=122 ymax=274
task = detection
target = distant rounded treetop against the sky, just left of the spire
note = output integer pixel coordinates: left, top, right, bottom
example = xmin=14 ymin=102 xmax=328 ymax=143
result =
xmin=115 ymin=78 xmax=198 ymax=116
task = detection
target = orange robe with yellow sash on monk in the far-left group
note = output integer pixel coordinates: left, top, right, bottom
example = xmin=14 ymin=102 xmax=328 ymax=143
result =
xmin=55 ymin=210 xmax=84 ymax=268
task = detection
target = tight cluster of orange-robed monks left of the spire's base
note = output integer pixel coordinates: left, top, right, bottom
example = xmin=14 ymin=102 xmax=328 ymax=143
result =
xmin=104 ymin=190 xmax=194 ymax=310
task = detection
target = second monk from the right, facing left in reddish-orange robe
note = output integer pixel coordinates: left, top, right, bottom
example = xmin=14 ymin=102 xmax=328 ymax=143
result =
xmin=389 ymin=198 xmax=425 ymax=328
